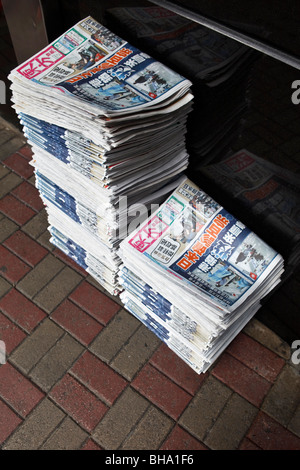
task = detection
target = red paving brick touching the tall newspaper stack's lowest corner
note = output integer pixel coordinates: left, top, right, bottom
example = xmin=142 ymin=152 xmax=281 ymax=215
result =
xmin=70 ymin=281 xmax=120 ymax=325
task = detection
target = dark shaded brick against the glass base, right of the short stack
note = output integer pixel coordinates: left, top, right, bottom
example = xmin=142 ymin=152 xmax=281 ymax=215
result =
xmin=243 ymin=318 xmax=291 ymax=359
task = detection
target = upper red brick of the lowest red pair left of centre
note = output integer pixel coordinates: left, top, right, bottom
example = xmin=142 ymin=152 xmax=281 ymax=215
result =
xmin=71 ymin=351 xmax=127 ymax=405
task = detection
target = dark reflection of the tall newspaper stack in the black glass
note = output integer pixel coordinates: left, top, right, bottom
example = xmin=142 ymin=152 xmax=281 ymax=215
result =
xmin=107 ymin=6 xmax=262 ymax=167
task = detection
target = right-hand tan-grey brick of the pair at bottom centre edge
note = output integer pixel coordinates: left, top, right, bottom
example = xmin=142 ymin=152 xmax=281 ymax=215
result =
xmin=121 ymin=406 xmax=173 ymax=450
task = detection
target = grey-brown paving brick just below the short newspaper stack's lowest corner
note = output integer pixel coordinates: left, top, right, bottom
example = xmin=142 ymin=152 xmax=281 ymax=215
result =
xmin=179 ymin=376 xmax=232 ymax=441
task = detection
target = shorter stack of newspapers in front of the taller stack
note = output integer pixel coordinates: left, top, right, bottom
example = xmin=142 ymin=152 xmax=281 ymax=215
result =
xmin=119 ymin=174 xmax=284 ymax=373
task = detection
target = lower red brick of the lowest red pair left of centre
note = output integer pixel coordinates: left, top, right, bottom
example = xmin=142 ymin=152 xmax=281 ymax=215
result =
xmin=50 ymin=374 xmax=108 ymax=431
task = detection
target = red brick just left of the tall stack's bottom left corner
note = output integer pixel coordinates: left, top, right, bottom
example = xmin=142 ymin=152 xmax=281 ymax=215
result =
xmin=4 ymin=230 xmax=48 ymax=267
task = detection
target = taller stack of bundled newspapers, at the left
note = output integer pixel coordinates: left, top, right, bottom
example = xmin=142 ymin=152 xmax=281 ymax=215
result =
xmin=9 ymin=17 xmax=193 ymax=294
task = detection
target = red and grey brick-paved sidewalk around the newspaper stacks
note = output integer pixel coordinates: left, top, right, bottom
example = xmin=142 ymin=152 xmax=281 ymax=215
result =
xmin=0 ymin=115 xmax=300 ymax=450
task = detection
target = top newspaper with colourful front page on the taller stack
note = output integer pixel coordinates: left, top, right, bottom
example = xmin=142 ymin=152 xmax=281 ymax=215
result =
xmin=9 ymin=17 xmax=191 ymax=116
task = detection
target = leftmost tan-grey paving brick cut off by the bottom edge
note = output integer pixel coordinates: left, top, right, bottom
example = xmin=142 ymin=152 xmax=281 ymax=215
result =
xmin=3 ymin=398 xmax=65 ymax=450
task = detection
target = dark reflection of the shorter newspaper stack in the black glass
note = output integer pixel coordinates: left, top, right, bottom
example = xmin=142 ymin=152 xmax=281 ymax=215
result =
xmin=201 ymin=149 xmax=300 ymax=272
